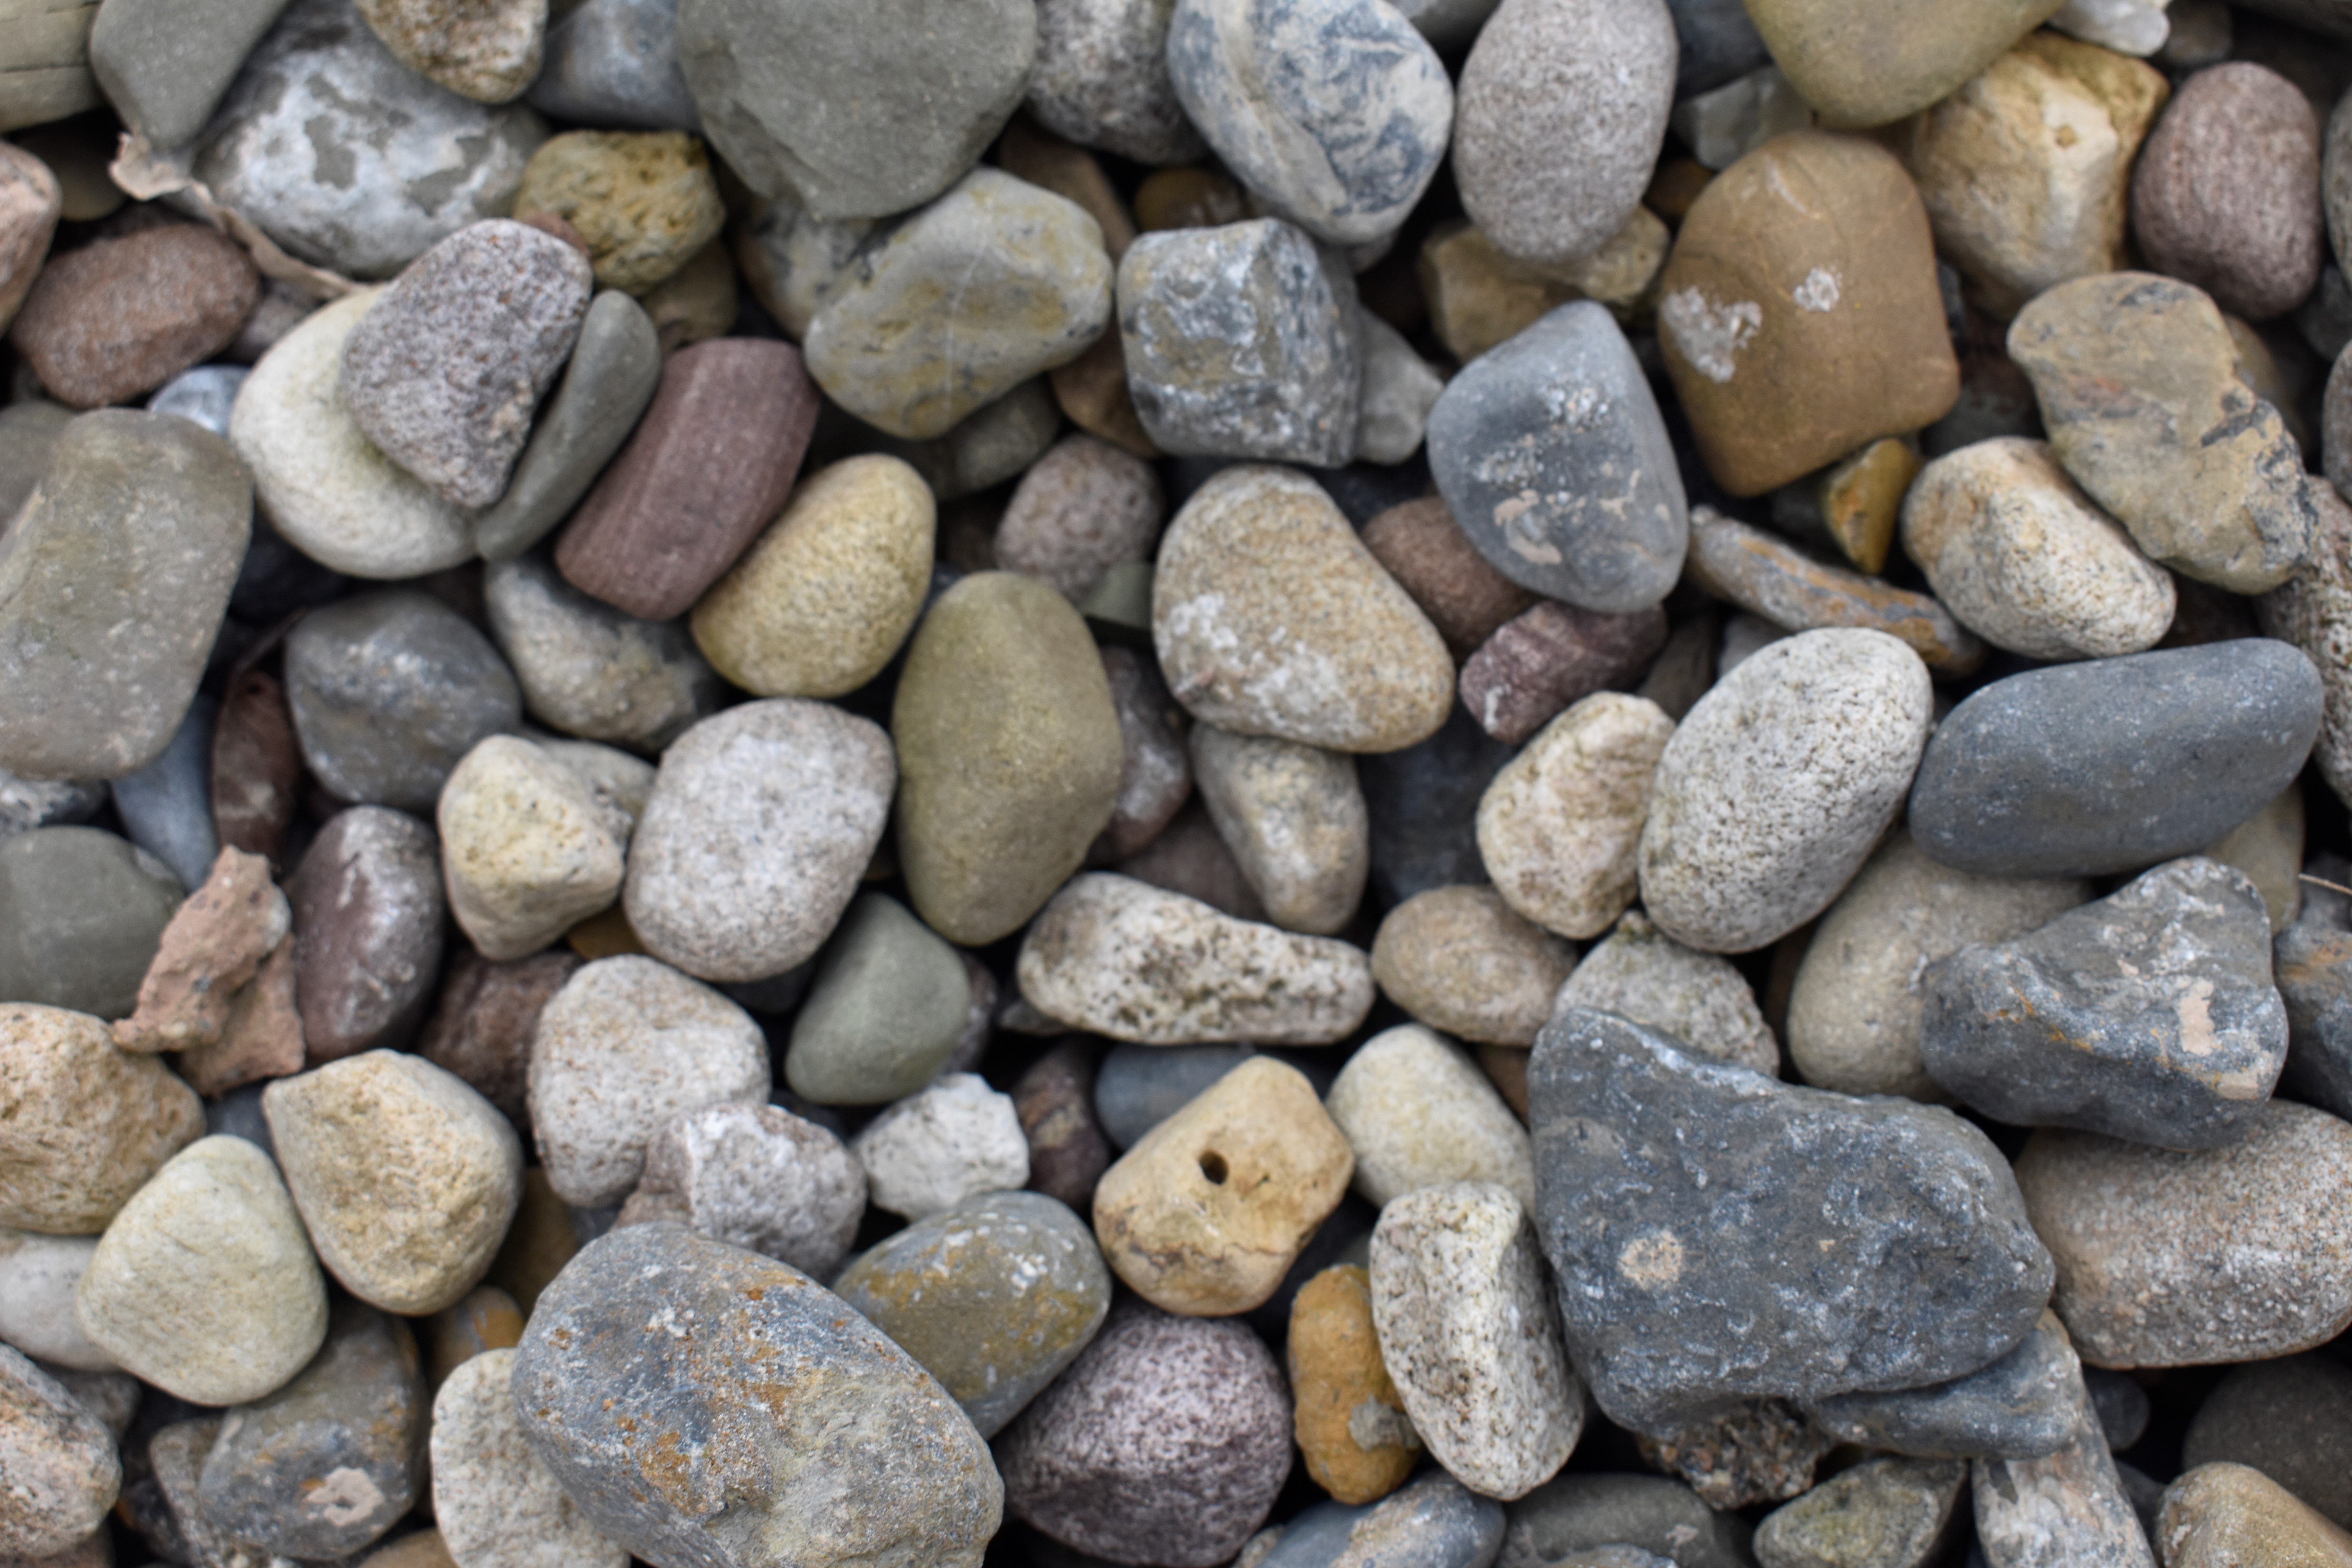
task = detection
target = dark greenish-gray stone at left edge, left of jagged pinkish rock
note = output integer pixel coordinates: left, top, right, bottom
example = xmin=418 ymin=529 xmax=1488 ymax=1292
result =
xmin=0 ymin=828 xmax=181 ymax=1018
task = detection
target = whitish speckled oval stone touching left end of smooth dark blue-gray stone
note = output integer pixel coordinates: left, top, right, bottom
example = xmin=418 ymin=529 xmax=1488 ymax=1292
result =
xmin=1642 ymin=630 xmax=1931 ymax=952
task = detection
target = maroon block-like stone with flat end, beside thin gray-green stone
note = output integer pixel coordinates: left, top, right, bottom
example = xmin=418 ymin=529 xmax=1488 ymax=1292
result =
xmin=555 ymin=339 xmax=818 ymax=621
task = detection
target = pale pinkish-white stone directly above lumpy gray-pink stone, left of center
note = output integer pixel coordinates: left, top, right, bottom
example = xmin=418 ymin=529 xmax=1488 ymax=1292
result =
xmin=529 ymin=955 xmax=769 ymax=1203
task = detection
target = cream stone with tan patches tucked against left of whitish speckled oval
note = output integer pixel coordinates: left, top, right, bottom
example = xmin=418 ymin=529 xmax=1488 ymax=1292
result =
xmin=1477 ymin=691 xmax=1675 ymax=938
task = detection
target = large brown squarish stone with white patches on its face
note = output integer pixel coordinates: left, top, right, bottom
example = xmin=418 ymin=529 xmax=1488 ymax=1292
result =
xmin=1658 ymin=136 xmax=1966 ymax=496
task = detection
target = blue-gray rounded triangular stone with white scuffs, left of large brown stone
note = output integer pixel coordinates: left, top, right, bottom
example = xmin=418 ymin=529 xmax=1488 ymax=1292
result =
xmin=1430 ymin=299 xmax=1691 ymax=616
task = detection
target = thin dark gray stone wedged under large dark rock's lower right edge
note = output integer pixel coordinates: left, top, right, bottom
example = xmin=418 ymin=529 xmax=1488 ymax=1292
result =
xmin=1811 ymin=1314 xmax=2074 ymax=1460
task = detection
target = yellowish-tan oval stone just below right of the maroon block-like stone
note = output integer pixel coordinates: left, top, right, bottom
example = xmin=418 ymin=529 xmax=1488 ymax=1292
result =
xmin=691 ymin=454 xmax=938 ymax=696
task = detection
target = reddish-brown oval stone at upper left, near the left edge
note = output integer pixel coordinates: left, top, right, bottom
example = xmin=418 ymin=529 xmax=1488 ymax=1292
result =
xmin=9 ymin=223 xmax=261 ymax=409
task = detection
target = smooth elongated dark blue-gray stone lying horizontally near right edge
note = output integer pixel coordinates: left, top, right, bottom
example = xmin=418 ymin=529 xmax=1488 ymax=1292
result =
xmin=1910 ymin=637 xmax=2321 ymax=877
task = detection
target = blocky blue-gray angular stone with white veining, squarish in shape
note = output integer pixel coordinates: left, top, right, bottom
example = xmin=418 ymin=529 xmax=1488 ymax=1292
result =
xmin=1117 ymin=219 xmax=1364 ymax=468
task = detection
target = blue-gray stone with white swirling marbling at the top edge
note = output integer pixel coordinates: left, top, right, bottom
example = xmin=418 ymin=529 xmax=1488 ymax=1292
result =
xmin=1169 ymin=0 xmax=1454 ymax=245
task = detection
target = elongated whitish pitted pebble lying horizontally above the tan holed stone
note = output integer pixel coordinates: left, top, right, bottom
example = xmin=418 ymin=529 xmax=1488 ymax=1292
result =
xmin=1018 ymin=872 xmax=1374 ymax=1046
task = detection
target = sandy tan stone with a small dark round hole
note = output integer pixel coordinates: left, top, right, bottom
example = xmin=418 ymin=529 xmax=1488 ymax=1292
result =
xmin=1094 ymin=1056 xmax=1355 ymax=1316
